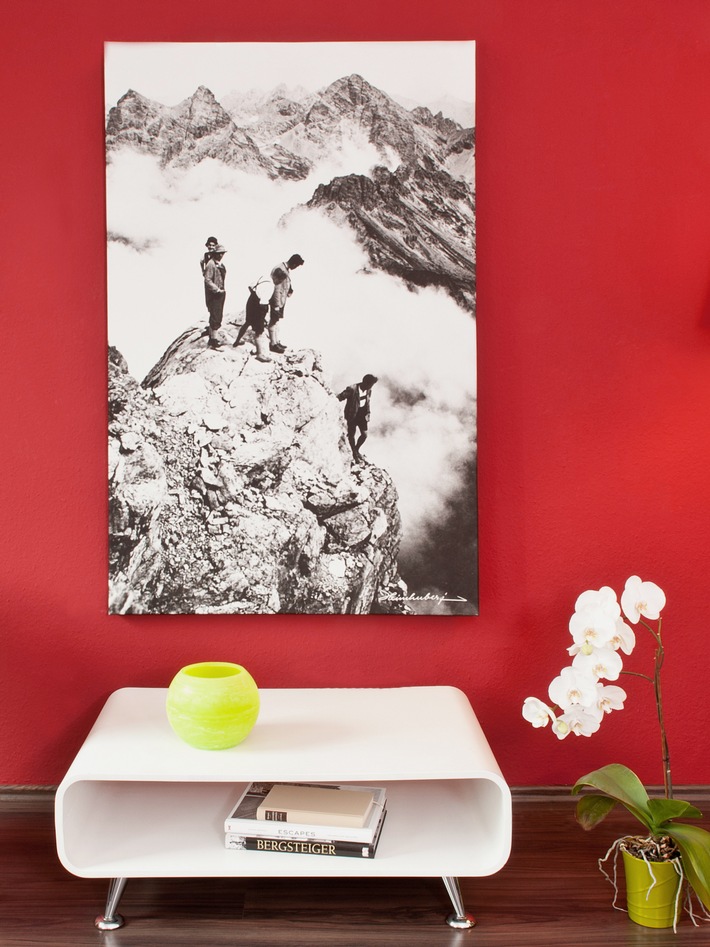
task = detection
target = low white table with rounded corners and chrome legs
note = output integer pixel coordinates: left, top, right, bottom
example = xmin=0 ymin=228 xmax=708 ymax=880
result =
xmin=55 ymin=687 xmax=512 ymax=930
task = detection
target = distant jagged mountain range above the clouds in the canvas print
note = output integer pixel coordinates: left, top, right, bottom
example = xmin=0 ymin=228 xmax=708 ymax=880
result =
xmin=106 ymin=75 xmax=475 ymax=310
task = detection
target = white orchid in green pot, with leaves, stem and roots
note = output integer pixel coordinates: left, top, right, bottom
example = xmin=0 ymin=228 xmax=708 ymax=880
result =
xmin=523 ymin=576 xmax=710 ymax=928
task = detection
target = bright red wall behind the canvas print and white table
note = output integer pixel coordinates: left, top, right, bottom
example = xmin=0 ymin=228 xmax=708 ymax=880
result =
xmin=0 ymin=0 xmax=710 ymax=785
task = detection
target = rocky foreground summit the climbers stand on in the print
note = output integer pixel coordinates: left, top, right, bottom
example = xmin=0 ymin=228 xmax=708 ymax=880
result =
xmin=109 ymin=334 xmax=406 ymax=614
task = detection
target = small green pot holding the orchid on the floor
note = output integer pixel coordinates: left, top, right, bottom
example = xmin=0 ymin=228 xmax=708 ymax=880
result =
xmin=621 ymin=849 xmax=681 ymax=927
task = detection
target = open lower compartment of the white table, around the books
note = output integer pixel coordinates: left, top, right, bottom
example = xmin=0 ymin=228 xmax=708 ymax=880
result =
xmin=57 ymin=779 xmax=511 ymax=878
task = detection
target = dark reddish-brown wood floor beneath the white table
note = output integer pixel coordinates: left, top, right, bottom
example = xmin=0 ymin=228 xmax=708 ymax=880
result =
xmin=0 ymin=792 xmax=710 ymax=947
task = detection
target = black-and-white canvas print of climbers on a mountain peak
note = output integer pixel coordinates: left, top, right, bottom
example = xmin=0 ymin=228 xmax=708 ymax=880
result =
xmin=105 ymin=42 xmax=478 ymax=615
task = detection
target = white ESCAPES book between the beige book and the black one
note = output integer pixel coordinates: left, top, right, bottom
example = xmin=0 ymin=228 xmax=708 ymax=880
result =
xmin=224 ymin=782 xmax=387 ymax=844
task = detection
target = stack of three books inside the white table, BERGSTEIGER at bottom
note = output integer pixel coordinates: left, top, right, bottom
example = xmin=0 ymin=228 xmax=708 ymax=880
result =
xmin=224 ymin=782 xmax=387 ymax=858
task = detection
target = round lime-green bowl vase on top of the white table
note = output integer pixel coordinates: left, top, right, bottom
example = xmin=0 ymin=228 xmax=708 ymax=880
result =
xmin=166 ymin=661 xmax=259 ymax=750
